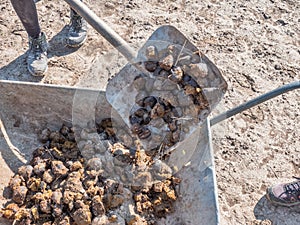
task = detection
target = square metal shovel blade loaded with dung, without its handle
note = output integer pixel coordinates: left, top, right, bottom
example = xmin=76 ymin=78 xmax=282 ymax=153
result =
xmin=106 ymin=25 xmax=227 ymax=165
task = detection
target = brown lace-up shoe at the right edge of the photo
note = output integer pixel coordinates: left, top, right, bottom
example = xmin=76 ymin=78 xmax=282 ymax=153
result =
xmin=266 ymin=178 xmax=300 ymax=206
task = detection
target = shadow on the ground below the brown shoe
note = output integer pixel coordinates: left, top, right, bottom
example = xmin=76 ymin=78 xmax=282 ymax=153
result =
xmin=254 ymin=196 xmax=300 ymax=225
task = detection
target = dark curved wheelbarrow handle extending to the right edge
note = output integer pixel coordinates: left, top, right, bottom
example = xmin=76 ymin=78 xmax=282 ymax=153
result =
xmin=210 ymin=81 xmax=300 ymax=126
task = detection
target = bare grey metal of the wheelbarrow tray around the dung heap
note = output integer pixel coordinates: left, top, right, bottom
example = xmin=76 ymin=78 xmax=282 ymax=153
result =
xmin=0 ymin=81 xmax=219 ymax=224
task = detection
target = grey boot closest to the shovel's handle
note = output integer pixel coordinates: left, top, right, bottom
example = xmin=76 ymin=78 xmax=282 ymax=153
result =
xmin=66 ymin=1 xmax=87 ymax=47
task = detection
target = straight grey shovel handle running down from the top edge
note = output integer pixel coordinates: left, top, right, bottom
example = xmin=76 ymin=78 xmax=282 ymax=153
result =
xmin=65 ymin=0 xmax=135 ymax=63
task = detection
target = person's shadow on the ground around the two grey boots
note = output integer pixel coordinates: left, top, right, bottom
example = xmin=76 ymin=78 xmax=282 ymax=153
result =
xmin=0 ymin=25 xmax=78 ymax=82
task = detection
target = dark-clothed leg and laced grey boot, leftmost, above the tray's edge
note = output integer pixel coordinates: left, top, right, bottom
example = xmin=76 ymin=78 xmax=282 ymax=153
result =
xmin=11 ymin=0 xmax=48 ymax=76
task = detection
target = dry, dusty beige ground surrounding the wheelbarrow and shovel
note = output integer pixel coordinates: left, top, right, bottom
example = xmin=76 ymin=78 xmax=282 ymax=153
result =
xmin=0 ymin=0 xmax=300 ymax=225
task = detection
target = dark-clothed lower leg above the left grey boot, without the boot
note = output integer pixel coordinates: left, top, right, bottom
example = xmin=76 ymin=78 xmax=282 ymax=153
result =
xmin=11 ymin=0 xmax=41 ymax=38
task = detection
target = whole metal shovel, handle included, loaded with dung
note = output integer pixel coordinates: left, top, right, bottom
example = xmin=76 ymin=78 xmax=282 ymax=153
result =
xmin=65 ymin=0 xmax=227 ymax=170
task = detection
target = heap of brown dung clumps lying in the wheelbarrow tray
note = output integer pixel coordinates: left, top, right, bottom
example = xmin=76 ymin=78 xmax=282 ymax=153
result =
xmin=0 ymin=124 xmax=180 ymax=225
